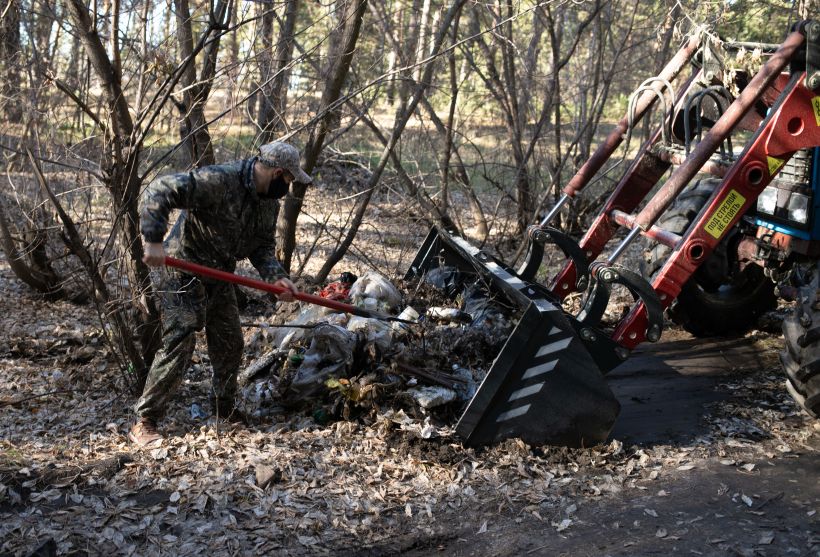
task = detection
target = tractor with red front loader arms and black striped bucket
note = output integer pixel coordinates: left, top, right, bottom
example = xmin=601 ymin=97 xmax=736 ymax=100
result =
xmin=406 ymin=20 xmax=820 ymax=446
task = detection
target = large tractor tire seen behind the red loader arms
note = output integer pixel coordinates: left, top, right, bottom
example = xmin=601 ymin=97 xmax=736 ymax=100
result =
xmin=642 ymin=179 xmax=777 ymax=337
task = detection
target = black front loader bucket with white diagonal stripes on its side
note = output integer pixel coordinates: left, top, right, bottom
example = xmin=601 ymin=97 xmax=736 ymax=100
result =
xmin=406 ymin=228 xmax=623 ymax=447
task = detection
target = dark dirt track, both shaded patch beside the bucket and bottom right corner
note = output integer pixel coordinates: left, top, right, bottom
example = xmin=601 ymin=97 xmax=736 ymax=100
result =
xmin=374 ymin=334 xmax=820 ymax=557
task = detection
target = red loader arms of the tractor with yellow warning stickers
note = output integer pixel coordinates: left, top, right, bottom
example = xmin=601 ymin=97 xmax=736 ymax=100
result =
xmin=550 ymin=22 xmax=820 ymax=349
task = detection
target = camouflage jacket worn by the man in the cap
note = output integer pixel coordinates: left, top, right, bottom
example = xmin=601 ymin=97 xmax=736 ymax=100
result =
xmin=140 ymin=157 xmax=287 ymax=282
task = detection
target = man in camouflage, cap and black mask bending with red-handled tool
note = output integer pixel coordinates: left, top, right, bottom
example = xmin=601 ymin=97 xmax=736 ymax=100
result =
xmin=128 ymin=141 xmax=311 ymax=447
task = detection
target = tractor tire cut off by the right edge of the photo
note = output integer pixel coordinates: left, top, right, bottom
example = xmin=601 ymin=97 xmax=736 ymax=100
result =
xmin=780 ymin=304 xmax=820 ymax=418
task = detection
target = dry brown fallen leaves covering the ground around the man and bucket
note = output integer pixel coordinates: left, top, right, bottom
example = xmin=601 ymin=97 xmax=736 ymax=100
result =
xmin=0 ymin=258 xmax=815 ymax=555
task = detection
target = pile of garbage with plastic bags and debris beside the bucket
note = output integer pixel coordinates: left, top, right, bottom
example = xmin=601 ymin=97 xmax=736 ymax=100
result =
xmin=239 ymin=267 xmax=517 ymax=422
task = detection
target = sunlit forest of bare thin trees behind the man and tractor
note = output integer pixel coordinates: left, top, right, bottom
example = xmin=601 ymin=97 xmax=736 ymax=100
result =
xmin=0 ymin=0 xmax=811 ymax=392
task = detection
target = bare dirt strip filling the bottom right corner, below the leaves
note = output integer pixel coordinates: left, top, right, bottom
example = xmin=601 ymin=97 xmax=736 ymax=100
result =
xmin=388 ymin=452 xmax=820 ymax=557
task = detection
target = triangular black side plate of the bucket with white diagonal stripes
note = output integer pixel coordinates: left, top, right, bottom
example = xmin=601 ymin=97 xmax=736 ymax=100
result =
xmin=456 ymin=300 xmax=620 ymax=447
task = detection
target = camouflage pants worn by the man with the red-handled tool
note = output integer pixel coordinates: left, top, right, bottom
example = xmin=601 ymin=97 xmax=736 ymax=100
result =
xmin=134 ymin=271 xmax=243 ymax=420
